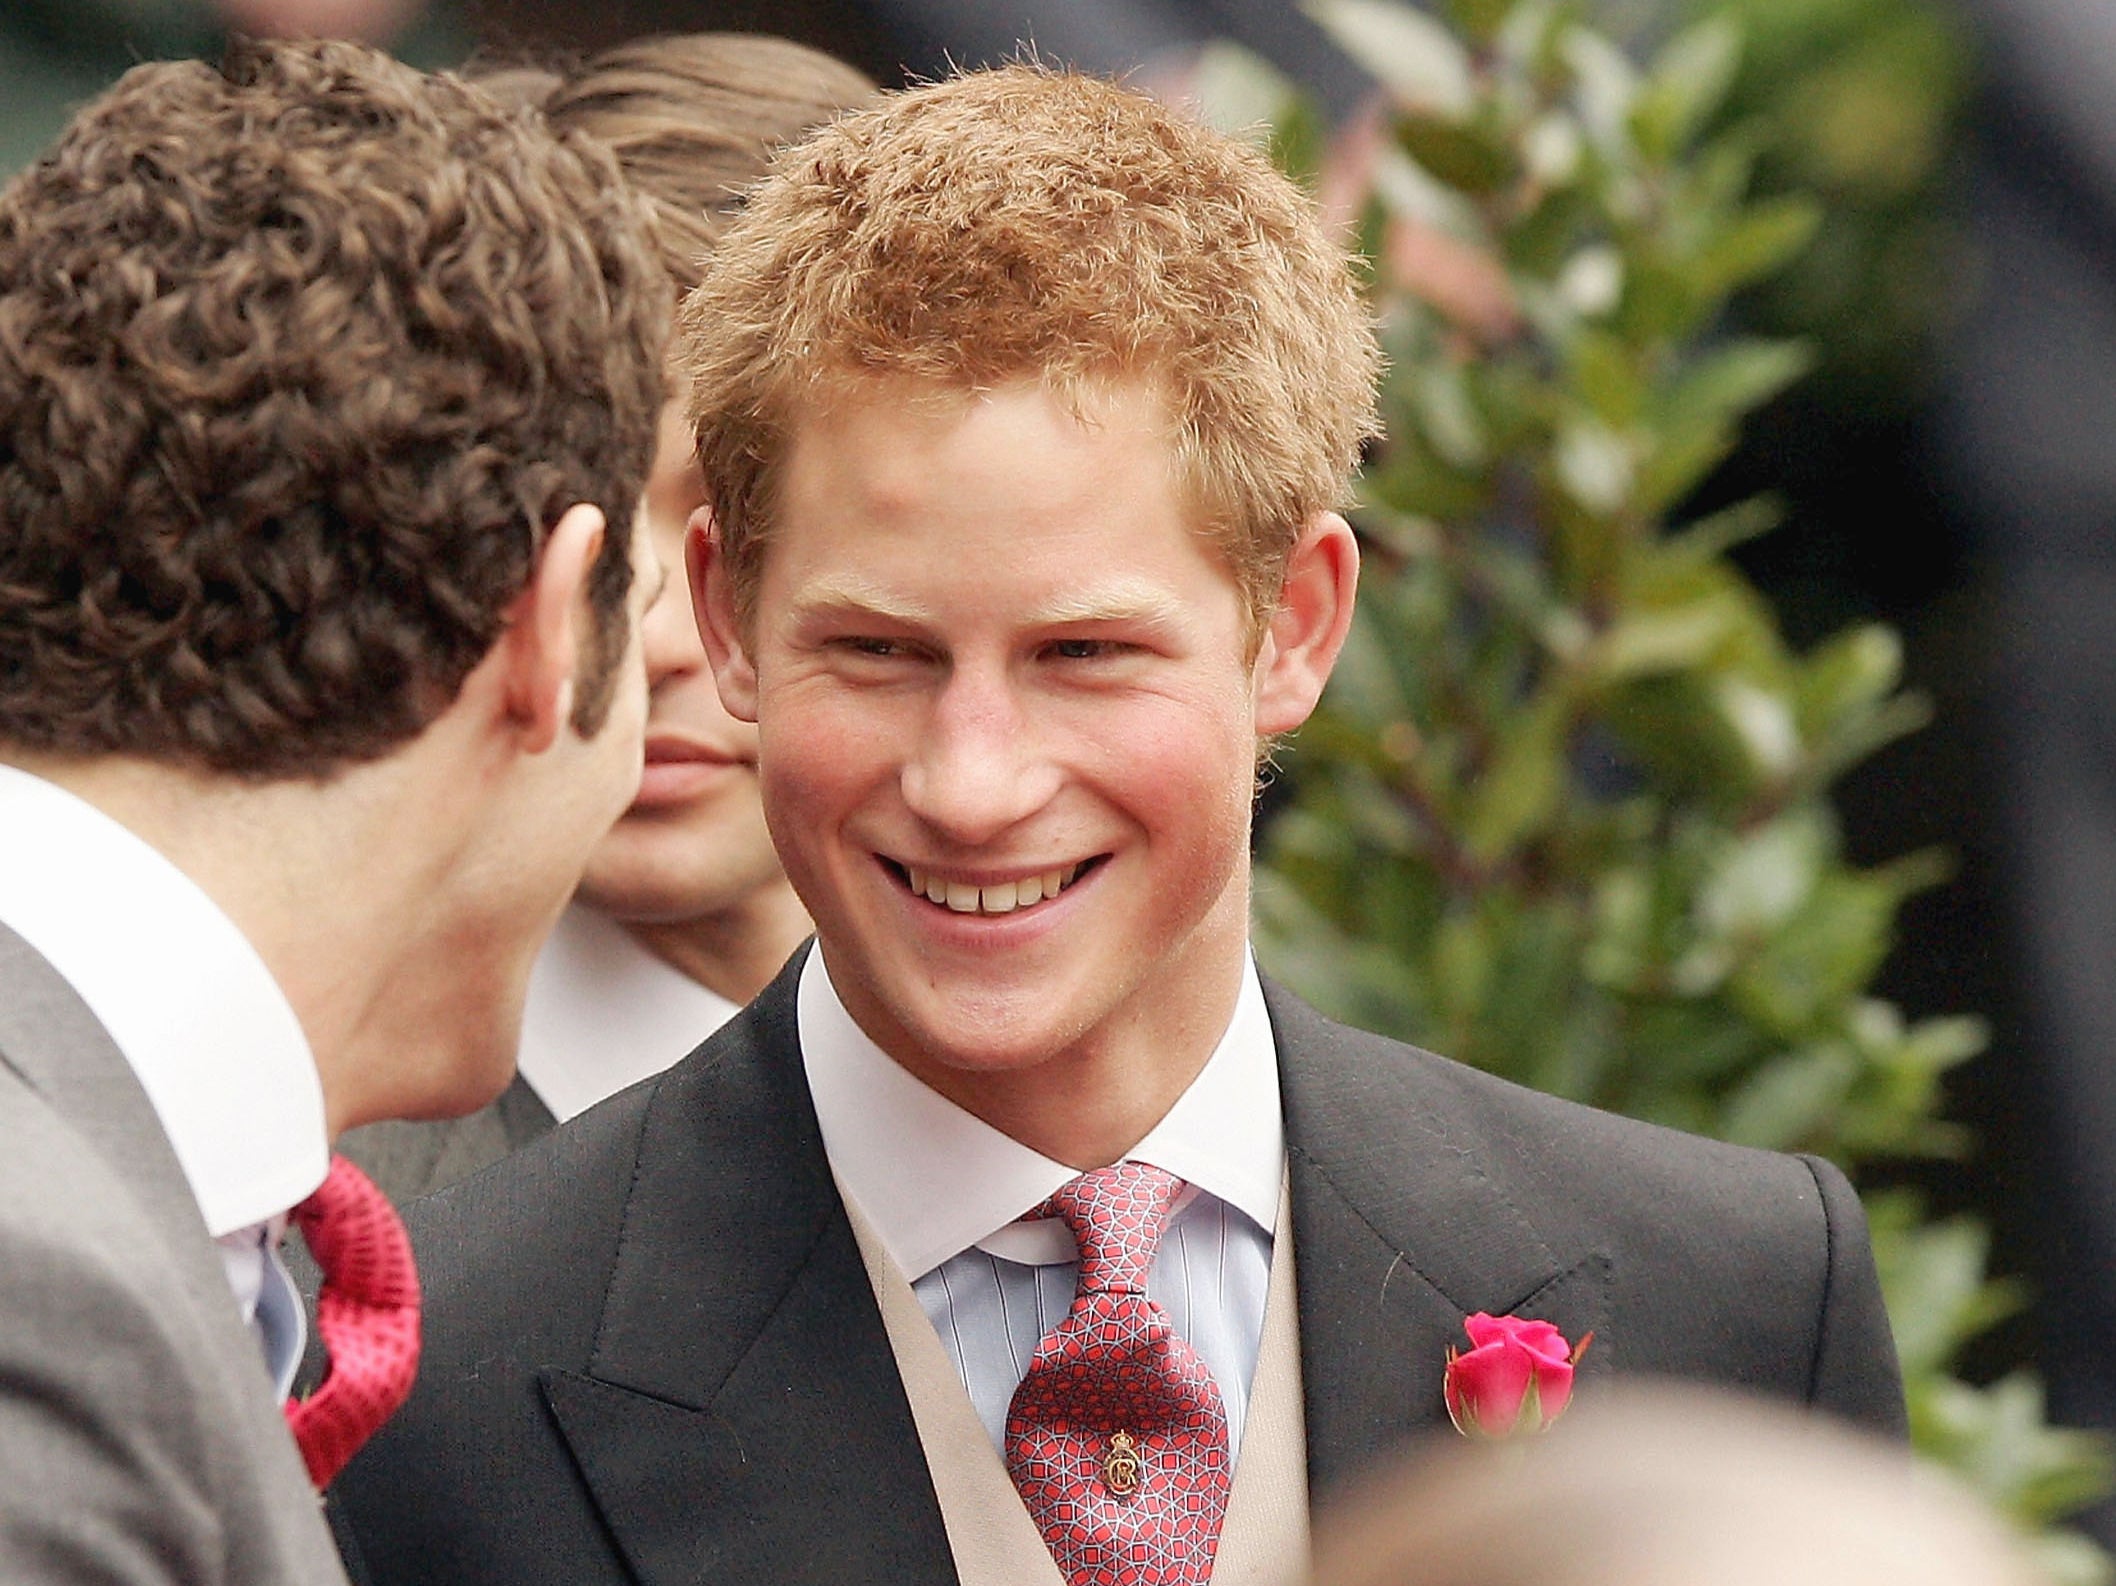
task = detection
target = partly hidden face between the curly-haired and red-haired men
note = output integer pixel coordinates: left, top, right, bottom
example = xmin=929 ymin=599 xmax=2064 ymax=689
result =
xmin=580 ymin=402 xmax=785 ymax=924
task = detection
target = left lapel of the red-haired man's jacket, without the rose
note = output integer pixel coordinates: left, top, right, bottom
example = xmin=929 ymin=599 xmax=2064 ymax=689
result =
xmin=542 ymin=954 xmax=954 ymax=1586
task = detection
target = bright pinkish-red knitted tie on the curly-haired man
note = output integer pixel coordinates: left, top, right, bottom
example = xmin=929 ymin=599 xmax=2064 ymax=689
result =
xmin=286 ymin=1157 xmax=419 ymax=1491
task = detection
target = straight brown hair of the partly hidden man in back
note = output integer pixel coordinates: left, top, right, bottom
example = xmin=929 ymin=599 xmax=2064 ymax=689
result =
xmin=482 ymin=34 xmax=876 ymax=292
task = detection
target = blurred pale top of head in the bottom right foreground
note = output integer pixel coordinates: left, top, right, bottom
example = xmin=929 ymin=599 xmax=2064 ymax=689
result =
xmin=1312 ymin=1381 xmax=2050 ymax=1586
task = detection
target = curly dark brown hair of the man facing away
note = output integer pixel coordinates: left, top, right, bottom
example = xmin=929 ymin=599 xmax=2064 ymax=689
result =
xmin=0 ymin=42 xmax=671 ymax=778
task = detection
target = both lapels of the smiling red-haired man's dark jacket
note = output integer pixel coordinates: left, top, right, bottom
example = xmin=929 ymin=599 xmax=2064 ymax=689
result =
xmin=544 ymin=954 xmax=1604 ymax=1586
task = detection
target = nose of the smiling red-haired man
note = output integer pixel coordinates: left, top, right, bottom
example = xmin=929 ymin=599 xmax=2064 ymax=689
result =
xmin=901 ymin=670 xmax=1060 ymax=844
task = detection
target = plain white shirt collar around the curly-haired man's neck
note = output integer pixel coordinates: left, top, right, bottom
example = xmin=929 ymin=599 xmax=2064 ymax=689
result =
xmin=0 ymin=766 xmax=330 ymax=1239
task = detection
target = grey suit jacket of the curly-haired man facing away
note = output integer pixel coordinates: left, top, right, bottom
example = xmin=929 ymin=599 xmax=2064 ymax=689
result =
xmin=0 ymin=928 xmax=345 ymax=1586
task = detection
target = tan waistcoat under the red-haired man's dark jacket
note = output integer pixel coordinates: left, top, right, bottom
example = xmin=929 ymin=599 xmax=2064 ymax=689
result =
xmin=838 ymin=1184 xmax=1308 ymax=1586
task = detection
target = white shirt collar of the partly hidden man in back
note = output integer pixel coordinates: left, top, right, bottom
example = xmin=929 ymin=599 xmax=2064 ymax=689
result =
xmin=518 ymin=903 xmax=736 ymax=1123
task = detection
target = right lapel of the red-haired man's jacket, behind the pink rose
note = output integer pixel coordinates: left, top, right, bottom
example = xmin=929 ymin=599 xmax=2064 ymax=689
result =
xmin=1265 ymin=983 xmax=1608 ymax=1501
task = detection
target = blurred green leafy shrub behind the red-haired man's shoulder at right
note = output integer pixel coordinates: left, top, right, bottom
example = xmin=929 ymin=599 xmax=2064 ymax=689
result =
xmin=1198 ymin=0 xmax=2108 ymax=1582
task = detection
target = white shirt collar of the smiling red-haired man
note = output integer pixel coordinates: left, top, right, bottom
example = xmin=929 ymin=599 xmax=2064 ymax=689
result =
xmin=800 ymin=947 xmax=1287 ymax=1279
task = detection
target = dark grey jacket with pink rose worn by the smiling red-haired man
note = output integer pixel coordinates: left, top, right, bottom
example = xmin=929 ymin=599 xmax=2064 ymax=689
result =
xmin=339 ymin=956 xmax=1902 ymax=1586
